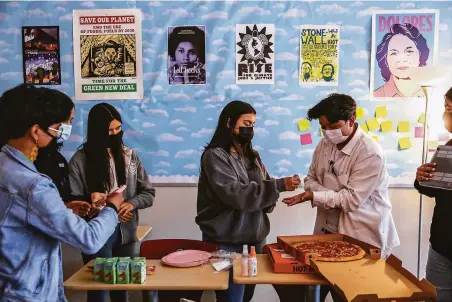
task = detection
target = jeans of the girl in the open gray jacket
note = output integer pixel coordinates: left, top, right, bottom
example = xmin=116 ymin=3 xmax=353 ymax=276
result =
xmin=82 ymin=223 xmax=135 ymax=302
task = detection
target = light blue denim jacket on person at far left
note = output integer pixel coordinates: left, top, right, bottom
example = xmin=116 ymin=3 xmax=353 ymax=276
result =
xmin=0 ymin=145 xmax=118 ymax=302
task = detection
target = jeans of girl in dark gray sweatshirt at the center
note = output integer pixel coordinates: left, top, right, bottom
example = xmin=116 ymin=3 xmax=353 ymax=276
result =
xmin=202 ymin=234 xmax=265 ymax=302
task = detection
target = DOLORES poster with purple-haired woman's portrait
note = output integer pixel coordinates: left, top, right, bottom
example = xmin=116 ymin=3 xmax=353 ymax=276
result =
xmin=370 ymin=9 xmax=439 ymax=101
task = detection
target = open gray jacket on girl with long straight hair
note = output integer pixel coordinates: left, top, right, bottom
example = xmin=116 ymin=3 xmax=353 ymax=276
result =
xmin=69 ymin=148 xmax=155 ymax=244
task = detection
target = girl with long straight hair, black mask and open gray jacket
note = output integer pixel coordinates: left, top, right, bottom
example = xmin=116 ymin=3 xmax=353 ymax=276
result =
xmin=69 ymin=103 xmax=155 ymax=302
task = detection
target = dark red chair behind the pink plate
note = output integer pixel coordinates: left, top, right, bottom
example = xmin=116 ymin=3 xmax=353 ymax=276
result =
xmin=140 ymin=239 xmax=218 ymax=302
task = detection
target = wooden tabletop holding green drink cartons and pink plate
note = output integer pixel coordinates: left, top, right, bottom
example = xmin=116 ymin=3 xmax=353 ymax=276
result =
xmin=64 ymin=260 xmax=229 ymax=290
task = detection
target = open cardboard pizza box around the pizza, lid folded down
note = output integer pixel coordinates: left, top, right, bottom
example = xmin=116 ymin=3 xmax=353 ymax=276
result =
xmin=278 ymin=234 xmax=436 ymax=302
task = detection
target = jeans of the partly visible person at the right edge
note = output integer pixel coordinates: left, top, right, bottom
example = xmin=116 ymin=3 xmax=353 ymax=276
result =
xmin=426 ymin=247 xmax=452 ymax=302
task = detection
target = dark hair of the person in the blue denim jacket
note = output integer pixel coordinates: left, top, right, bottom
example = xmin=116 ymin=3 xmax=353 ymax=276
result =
xmin=0 ymin=84 xmax=74 ymax=147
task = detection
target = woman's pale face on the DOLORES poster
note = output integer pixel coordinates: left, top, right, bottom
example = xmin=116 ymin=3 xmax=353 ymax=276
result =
xmin=387 ymin=34 xmax=420 ymax=79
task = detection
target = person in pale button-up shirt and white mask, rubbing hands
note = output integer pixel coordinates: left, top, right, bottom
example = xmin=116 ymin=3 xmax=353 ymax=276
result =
xmin=283 ymin=94 xmax=400 ymax=301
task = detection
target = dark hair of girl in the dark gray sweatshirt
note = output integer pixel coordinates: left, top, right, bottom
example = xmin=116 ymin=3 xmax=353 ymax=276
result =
xmin=201 ymin=101 xmax=260 ymax=169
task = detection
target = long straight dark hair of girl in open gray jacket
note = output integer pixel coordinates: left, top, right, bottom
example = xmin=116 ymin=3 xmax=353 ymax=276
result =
xmin=83 ymin=103 xmax=126 ymax=192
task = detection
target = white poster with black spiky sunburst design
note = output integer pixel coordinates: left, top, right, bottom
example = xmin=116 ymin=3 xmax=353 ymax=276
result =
xmin=236 ymin=24 xmax=275 ymax=84
